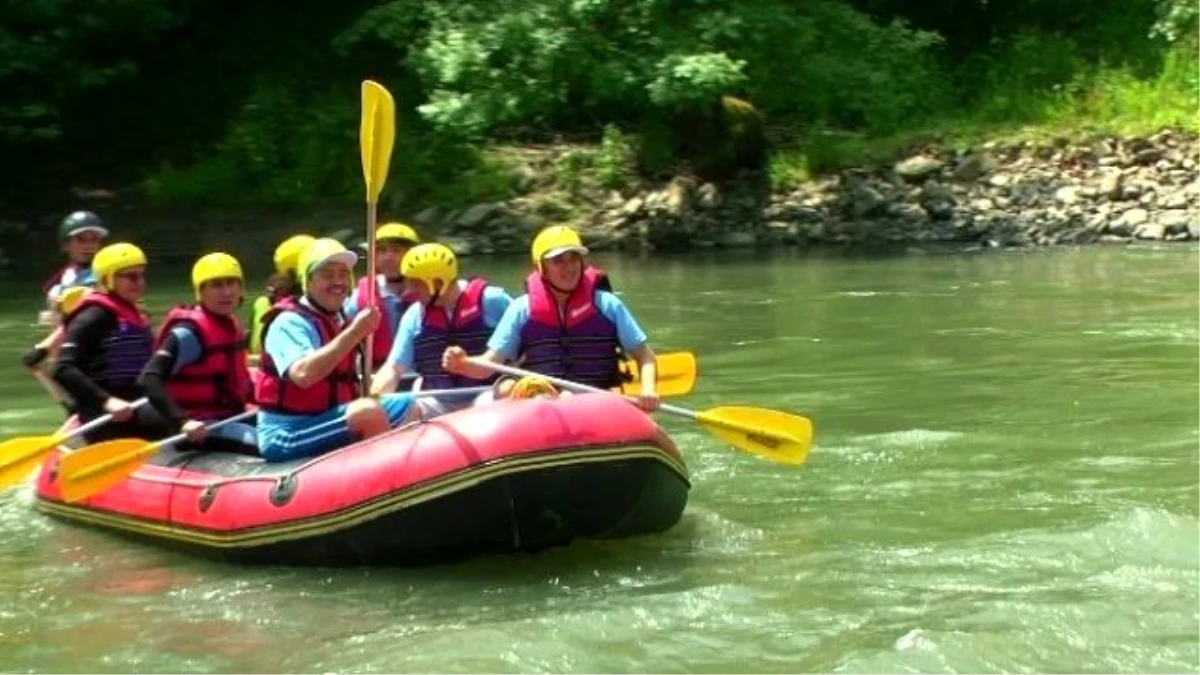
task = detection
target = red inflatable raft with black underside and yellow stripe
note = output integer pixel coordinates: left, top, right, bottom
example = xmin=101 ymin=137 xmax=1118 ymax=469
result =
xmin=36 ymin=394 xmax=690 ymax=566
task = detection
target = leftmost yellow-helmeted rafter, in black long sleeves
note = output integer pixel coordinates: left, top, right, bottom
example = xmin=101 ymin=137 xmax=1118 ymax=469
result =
xmin=53 ymin=244 xmax=170 ymax=443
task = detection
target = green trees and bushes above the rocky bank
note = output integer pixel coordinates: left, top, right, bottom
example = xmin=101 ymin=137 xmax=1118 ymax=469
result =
xmin=11 ymin=0 xmax=1200 ymax=208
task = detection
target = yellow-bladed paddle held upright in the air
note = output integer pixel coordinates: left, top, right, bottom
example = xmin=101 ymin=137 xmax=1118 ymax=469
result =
xmin=359 ymin=79 xmax=396 ymax=396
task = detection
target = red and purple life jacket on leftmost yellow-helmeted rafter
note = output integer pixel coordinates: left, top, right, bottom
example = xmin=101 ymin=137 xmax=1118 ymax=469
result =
xmin=66 ymin=291 xmax=154 ymax=395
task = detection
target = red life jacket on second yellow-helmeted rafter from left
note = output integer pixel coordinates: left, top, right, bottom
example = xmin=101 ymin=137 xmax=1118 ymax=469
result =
xmin=156 ymin=305 xmax=250 ymax=420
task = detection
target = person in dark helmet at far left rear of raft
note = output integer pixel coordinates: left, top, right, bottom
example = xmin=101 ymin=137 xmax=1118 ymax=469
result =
xmin=20 ymin=211 xmax=108 ymax=368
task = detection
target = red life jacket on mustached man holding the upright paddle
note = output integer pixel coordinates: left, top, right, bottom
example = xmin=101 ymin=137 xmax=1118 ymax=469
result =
xmin=254 ymin=298 xmax=359 ymax=414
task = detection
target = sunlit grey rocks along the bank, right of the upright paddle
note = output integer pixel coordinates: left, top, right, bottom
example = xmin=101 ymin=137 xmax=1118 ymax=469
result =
xmin=413 ymin=131 xmax=1200 ymax=252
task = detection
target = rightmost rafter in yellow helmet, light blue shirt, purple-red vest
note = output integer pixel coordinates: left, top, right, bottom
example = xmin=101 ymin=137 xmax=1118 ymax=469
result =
xmin=442 ymin=226 xmax=660 ymax=412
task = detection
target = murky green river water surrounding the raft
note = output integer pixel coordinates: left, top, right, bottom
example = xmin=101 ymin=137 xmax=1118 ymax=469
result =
xmin=0 ymin=245 xmax=1200 ymax=674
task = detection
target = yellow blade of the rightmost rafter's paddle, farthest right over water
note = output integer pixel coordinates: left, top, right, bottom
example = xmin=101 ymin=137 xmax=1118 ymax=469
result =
xmin=696 ymin=406 xmax=812 ymax=464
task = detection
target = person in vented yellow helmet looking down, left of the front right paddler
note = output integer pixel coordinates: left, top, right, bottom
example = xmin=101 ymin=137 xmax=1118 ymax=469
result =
xmin=371 ymin=239 xmax=512 ymax=418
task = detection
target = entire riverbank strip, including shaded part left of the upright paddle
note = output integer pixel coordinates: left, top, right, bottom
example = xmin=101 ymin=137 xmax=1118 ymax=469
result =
xmin=22 ymin=130 xmax=1200 ymax=269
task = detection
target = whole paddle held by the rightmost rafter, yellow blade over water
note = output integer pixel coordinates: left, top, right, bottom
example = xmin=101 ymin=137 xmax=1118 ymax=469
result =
xmin=467 ymin=357 xmax=812 ymax=464
